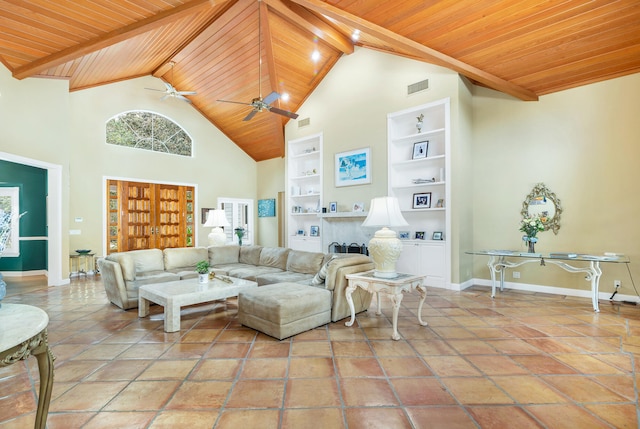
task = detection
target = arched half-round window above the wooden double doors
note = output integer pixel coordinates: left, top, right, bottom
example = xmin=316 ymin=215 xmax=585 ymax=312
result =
xmin=107 ymin=110 xmax=193 ymax=156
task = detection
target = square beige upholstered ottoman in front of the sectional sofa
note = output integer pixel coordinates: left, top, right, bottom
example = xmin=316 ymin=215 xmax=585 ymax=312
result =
xmin=238 ymin=283 xmax=331 ymax=340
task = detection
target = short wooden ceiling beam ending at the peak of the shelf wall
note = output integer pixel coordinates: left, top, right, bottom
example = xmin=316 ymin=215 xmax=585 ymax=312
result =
xmin=263 ymin=0 xmax=353 ymax=55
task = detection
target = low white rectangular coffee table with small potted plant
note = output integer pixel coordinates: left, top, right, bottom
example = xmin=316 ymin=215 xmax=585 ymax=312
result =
xmin=138 ymin=277 xmax=258 ymax=332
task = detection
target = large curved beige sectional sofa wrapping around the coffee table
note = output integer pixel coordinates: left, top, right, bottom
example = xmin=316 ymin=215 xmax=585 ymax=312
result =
xmin=98 ymin=245 xmax=373 ymax=322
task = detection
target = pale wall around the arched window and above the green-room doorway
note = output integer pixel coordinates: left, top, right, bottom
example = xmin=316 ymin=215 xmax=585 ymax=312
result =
xmin=0 ymin=66 xmax=257 ymax=278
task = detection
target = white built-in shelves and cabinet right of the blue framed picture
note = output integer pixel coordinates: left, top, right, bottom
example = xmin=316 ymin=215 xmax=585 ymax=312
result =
xmin=387 ymin=98 xmax=451 ymax=287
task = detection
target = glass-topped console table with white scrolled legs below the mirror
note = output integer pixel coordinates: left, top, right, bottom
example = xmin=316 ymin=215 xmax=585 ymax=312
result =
xmin=466 ymin=250 xmax=629 ymax=311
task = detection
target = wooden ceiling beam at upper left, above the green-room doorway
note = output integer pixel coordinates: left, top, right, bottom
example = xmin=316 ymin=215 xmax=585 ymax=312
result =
xmin=13 ymin=0 xmax=228 ymax=79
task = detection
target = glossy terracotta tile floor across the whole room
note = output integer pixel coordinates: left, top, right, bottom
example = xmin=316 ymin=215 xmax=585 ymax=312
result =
xmin=0 ymin=277 xmax=640 ymax=429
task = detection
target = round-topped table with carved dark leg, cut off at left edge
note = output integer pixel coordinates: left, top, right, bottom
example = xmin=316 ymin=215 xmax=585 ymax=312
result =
xmin=0 ymin=304 xmax=54 ymax=429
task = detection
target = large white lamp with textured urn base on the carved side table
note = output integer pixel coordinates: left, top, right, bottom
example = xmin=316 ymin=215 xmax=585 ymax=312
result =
xmin=362 ymin=197 xmax=409 ymax=279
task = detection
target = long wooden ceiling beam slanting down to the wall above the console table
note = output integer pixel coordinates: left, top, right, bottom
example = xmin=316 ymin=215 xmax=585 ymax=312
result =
xmin=291 ymin=0 xmax=538 ymax=101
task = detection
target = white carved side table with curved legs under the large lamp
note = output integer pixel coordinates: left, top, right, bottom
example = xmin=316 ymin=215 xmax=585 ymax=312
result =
xmin=345 ymin=271 xmax=427 ymax=341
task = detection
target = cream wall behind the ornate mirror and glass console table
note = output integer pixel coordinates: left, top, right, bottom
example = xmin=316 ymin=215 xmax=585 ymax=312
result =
xmin=473 ymin=74 xmax=640 ymax=295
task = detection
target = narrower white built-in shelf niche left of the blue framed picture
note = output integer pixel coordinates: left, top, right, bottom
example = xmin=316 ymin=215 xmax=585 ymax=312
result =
xmin=287 ymin=133 xmax=323 ymax=252
